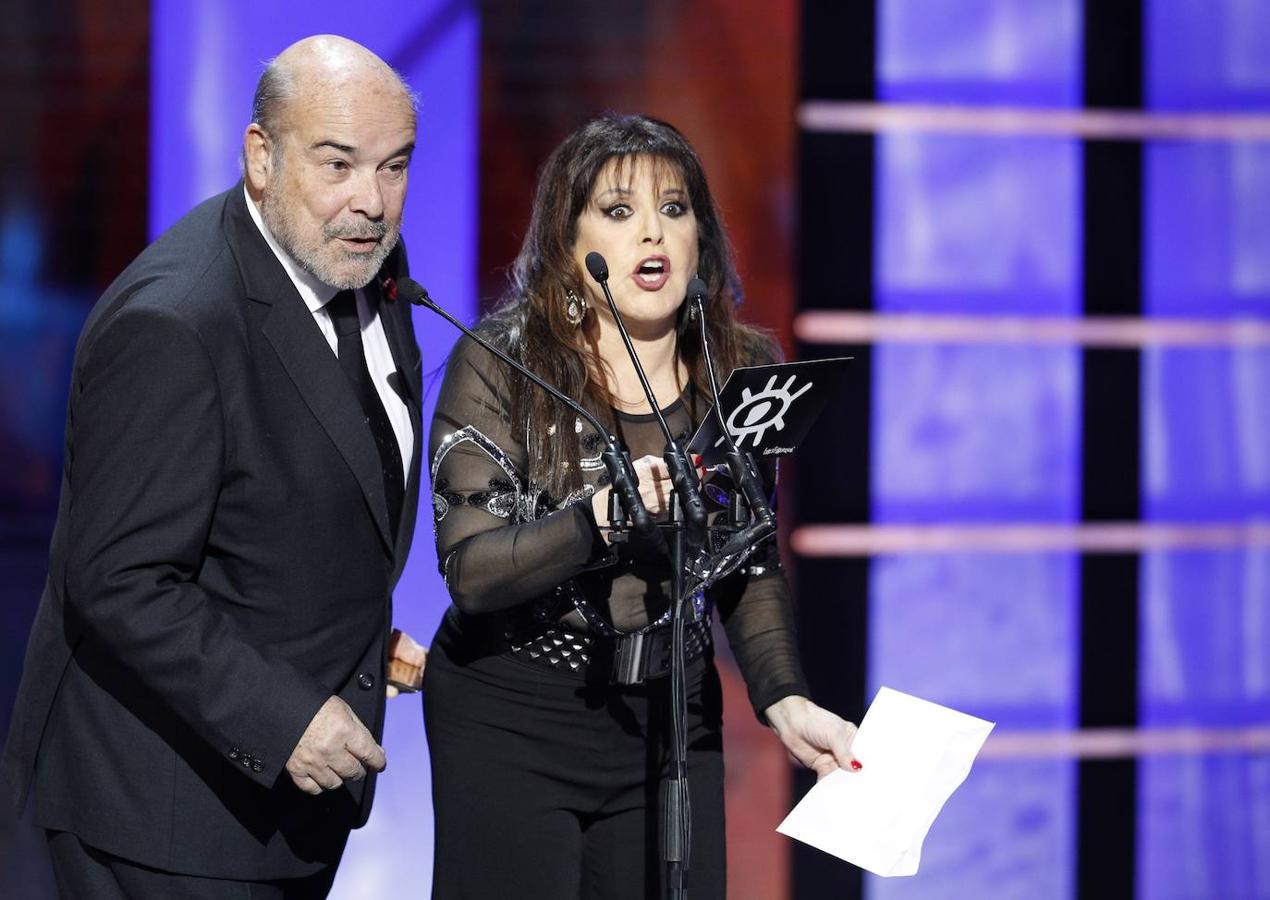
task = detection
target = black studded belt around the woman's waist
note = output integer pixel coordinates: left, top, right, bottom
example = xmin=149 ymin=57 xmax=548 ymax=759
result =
xmin=503 ymin=616 xmax=710 ymax=684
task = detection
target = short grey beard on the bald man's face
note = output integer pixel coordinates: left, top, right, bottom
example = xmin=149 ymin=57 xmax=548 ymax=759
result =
xmin=260 ymin=177 xmax=401 ymax=285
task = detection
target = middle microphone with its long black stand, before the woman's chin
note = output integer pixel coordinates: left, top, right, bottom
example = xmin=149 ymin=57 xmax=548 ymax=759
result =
xmin=585 ymin=251 xmax=706 ymax=900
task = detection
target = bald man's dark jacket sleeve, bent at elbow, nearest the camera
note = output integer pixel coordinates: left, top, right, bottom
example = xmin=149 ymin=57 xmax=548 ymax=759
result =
xmin=66 ymin=303 xmax=329 ymax=784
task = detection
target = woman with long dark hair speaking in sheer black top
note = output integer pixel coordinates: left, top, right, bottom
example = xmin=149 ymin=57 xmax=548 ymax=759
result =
xmin=424 ymin=116 xmax=859 ymax=900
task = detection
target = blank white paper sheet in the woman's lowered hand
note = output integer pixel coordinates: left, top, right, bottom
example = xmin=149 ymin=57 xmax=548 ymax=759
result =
xmin=776 ymin=688 xmax=994 ymax=876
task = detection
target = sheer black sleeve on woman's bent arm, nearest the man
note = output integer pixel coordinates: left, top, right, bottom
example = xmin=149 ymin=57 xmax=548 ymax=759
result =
xmin=429 ymin=338 xmax=608 ymax=613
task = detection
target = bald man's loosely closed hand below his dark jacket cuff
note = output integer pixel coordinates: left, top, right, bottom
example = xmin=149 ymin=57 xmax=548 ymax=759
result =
xmin=287 ymin=697 xmax=387 ymax=796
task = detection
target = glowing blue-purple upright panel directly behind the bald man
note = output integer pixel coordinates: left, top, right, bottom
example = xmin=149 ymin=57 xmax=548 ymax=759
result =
xmin=150 ymin=0 xmax=479 ymax=900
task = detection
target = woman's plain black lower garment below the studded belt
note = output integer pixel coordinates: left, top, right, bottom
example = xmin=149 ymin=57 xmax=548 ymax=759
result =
xmin=423 ymin=626 xmax=726 ymax=900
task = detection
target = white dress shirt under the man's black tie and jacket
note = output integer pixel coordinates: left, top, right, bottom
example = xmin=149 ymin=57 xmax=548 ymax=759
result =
xmin=243 ymin=187 xmax=414 ymax=481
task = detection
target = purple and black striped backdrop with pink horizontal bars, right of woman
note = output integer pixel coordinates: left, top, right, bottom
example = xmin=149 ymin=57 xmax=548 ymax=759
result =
xmin=791 ymin=0 xmax=1270 ymax=900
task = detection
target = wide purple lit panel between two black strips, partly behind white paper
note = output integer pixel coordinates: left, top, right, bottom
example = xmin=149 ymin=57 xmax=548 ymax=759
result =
xmin=866 ymin=0 xmax=1081 ymax=900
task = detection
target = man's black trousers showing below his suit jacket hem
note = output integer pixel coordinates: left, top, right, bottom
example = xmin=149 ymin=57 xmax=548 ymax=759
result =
xmin=48 ymin=831 xmax=335 ymax=900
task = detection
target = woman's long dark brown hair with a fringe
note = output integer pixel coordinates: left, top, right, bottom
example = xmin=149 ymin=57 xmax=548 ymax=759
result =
xmin=481 ymin=114 xmax=777 ymax=498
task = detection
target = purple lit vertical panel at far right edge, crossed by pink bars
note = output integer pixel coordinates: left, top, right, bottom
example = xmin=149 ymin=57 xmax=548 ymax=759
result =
xmin=1138 ymin=0 xmax=1270 ymax=900
